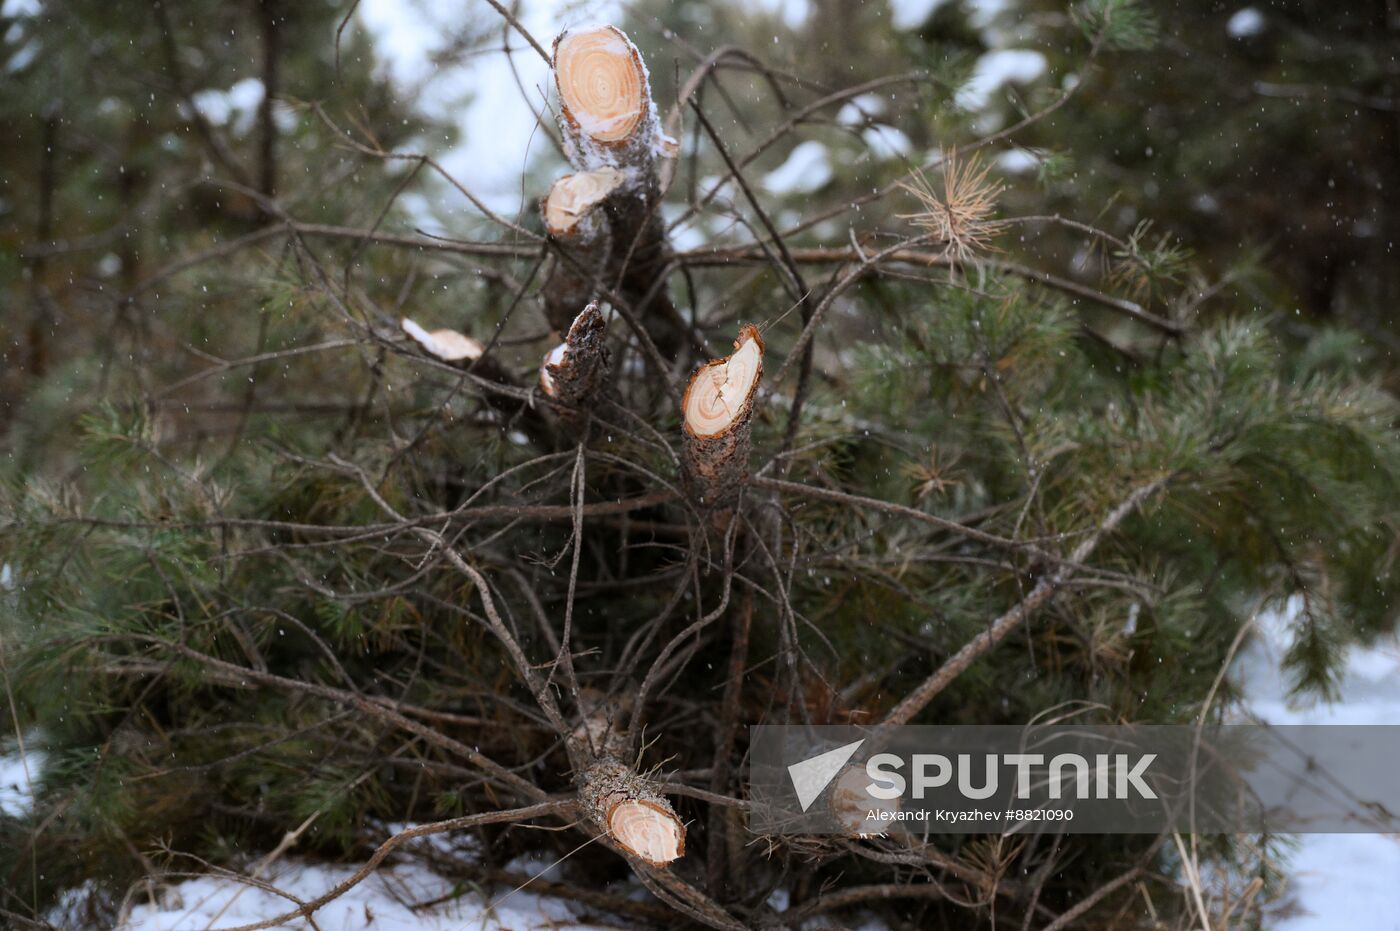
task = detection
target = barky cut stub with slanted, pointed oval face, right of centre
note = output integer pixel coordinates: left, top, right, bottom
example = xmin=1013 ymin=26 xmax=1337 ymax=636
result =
xmin=682 ymin=323 xmax=763 ymax=515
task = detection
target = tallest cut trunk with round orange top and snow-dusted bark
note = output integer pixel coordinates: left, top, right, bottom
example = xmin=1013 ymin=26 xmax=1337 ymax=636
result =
xmin=554 ymin=25 xmax=686 ymax=356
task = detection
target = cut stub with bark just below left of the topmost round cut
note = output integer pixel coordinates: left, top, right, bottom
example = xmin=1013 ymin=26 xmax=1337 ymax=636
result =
xmin=540 ymin=168 xmax=623 ymax=333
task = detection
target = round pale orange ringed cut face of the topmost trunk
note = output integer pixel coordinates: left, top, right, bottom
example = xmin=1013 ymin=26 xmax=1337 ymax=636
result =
xmin=554 ymin=25 xmax=650 ymax=144
